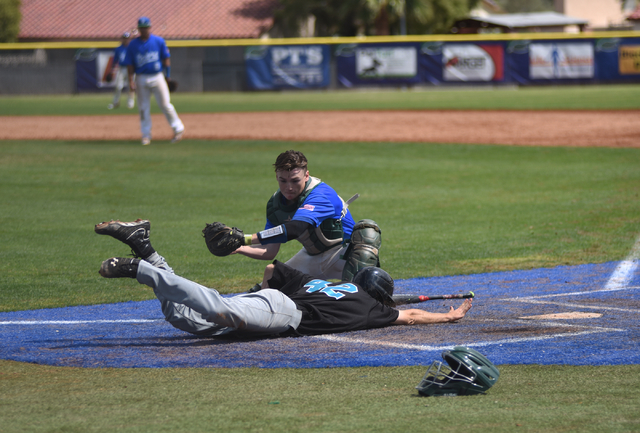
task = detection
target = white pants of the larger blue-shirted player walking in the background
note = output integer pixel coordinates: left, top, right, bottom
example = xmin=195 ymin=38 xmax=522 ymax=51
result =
xmin=136 ymin=72 xmax=184 ymax=139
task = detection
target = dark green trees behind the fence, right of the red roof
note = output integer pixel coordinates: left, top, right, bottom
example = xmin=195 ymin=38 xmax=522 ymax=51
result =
xmin=274 ymin=0 xmax=479 ymax=37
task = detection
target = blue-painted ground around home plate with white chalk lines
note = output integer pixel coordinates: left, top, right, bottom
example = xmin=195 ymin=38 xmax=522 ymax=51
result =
xmin=0 ymin=262 xmax=640 ymax=368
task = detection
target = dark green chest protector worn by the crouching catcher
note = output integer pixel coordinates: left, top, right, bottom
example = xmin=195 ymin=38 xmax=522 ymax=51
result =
xmin=267 ymin=176 xmax=344 ymax=256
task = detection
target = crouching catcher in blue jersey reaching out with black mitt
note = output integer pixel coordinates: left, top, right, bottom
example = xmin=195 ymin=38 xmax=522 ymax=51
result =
xmin=204 ymin=150 xmax=382 ymax=291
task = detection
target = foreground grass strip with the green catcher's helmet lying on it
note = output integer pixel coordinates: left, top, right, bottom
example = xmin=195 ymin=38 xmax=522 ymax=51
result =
xmin=0 ymin=361 xmax=640 ymax=433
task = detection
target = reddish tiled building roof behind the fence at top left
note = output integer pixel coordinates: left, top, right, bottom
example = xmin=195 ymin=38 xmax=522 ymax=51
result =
xmin=18 ymin=0 xmax=277 ymax=41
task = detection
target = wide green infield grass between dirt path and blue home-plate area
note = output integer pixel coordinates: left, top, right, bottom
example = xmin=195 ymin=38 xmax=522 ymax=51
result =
xmin=0 ymin=140 xmax=640 ymax=311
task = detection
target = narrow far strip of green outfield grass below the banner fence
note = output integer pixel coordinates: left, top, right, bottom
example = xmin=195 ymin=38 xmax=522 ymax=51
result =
xmin=0 ymin=84 xmax=640 ymax=116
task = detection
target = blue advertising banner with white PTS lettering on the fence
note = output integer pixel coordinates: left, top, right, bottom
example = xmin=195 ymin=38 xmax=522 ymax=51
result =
xmin=244 ymin=45 xmax=331 ymax=90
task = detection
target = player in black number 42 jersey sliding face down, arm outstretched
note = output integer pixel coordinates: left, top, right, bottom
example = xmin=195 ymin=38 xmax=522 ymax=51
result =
xmin=95 ymin=220 xmax=471 ymax=337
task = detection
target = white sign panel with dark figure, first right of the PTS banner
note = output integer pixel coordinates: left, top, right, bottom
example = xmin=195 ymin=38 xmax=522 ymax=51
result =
xmin=356 ymin=47 xmax=418 ymax=78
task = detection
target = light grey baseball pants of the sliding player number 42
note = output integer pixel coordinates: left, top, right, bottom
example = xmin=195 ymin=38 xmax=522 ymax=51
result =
xmin=137 ymin=261 xmax=302 ymax=336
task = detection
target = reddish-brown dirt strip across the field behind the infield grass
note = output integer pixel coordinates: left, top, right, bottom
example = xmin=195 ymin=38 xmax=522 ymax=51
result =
xmin=0 ymin=110 xmax=640 ymax=147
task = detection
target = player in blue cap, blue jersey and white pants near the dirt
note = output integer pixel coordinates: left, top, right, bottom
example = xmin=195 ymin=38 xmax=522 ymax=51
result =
xmin=122 ymin=17 xmax=184 ymax=146
